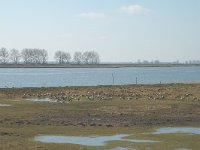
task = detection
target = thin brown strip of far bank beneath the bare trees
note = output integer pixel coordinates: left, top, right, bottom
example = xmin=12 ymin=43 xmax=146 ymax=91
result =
xmin=0 ymin=64 xmax=200 ymax=68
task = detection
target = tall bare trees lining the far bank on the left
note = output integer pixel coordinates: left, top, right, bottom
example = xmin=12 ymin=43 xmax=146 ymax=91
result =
xmin=0 ymin=48 xmax=100 ymax=64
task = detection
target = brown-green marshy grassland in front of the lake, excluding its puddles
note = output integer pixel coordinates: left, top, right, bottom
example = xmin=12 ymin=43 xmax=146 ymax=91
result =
xmin=0 ymin=84 xmax=200 ymax=150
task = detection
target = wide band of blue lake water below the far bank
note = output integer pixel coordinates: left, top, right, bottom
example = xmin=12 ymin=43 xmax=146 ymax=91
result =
xmin=0 ymin=67 xmax=200 ymax=87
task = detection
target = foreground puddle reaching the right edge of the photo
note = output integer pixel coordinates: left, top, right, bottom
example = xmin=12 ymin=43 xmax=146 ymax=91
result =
xmin=153 ymin=127 xmax=200 ymax=134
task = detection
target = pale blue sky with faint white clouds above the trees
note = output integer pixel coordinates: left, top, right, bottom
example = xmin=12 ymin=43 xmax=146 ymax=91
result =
xmin=0 ymin=0 xmax=200 ymax=62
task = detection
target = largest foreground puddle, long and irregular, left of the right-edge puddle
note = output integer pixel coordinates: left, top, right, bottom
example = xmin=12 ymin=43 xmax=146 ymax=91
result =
xmin=34 ymin=134 xmax=159 ymax=146
